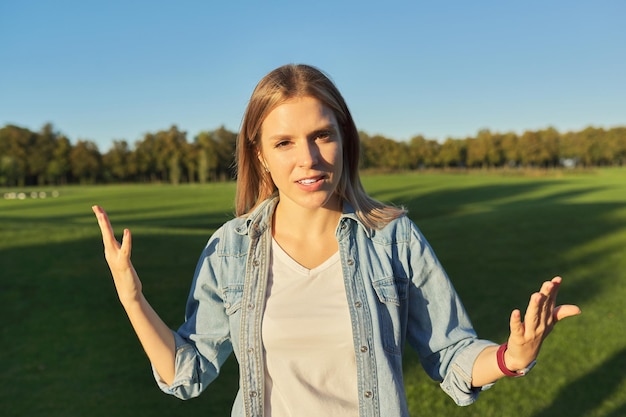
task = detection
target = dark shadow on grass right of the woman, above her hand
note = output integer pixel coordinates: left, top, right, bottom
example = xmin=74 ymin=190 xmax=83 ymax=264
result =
xmin=370 ymin=181 xmax=626 ymax=337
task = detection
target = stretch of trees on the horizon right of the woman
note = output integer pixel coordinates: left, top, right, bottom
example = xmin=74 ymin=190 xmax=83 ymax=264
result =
xmin=361 ymin=127 xmax=626 ymax=169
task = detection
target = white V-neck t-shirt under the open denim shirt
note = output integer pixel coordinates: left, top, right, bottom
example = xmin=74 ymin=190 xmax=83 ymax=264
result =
xmin=262 ymin=237 xmax=359 ymax=417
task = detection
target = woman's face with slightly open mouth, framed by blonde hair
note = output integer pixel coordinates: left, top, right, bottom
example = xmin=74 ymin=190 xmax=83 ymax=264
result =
xmin=259 ymin=96 xmax=343 ymax=210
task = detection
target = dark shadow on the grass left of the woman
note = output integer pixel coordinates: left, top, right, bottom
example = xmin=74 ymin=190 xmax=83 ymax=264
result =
xmin=0 ymin=213 xmax=238 ymax=417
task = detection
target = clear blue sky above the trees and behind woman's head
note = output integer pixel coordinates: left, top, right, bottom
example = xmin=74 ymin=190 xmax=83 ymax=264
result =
xmin=0 ymin=0 xmax=626 ymax=151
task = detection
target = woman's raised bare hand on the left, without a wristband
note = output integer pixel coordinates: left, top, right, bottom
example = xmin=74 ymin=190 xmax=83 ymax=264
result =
xmin=91 ymin=206 xmax=141 ymax=306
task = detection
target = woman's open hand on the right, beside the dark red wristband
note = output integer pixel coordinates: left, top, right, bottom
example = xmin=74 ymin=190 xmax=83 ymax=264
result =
xmin=504 ymin=277 xmax=581 ymax=371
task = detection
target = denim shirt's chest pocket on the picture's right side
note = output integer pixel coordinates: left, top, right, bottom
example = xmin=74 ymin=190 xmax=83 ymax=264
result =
xmin=372 ymin=276 xmax=408 ymax=355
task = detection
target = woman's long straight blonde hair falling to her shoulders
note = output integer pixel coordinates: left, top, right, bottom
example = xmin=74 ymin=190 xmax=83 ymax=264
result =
xmin=235 ymin=64 xmax=405 ymax=229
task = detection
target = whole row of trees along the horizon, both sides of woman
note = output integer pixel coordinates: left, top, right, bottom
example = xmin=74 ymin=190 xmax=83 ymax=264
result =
xmin=0 ymin=120 xmax=626 ymax=186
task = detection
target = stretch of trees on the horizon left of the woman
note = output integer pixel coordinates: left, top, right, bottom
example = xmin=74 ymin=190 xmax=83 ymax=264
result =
xmin=0 ymin=124 xmax=237 ymax=186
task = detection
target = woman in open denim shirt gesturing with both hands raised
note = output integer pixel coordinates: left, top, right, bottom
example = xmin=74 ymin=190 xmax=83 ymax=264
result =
xmin=93 ymin=65 xmax=580 ymax=417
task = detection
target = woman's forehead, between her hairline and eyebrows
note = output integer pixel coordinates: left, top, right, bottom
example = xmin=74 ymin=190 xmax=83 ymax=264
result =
xmin=261 ymin=96 xmax=337 ymax=136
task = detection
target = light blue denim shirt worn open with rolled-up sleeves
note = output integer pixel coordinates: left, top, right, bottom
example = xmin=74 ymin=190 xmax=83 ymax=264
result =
xmin=155 ymin=198 xmax=493 ymax=417
